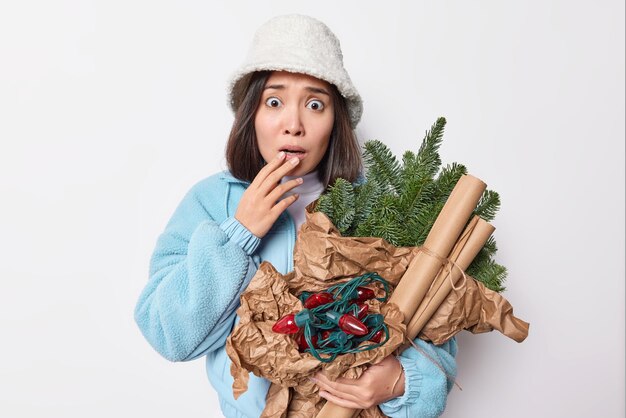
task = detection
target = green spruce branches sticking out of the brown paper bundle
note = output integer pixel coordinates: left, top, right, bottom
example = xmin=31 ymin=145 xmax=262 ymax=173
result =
xmin=316 ymin=118 xmax=507 ymax=292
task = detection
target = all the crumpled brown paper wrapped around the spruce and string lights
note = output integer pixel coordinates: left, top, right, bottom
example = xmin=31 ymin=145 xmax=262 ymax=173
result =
xmin=226 ymin=211 xmax=528 ymax=418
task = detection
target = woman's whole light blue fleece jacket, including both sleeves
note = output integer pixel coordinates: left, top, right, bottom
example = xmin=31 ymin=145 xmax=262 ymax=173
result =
xmin=135 ymin=172 xmax=456 ymax=418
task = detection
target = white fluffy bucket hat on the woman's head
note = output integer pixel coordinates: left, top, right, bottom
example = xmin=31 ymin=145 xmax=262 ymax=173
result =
xmin=228 ymin=15 xmax=363 ymax=129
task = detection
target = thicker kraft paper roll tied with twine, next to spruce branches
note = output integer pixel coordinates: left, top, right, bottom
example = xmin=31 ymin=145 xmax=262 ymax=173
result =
xmin=389 ymin=175 xmax=487 ymax=324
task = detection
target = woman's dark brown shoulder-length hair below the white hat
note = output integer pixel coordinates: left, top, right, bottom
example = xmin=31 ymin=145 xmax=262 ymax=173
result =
xmin=226 ymin=71 xmax=362 ymax=186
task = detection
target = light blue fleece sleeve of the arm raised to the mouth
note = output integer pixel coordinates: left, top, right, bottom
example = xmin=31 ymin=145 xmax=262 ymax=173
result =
xmin=135 ymin=183 xmax=260 ymax=361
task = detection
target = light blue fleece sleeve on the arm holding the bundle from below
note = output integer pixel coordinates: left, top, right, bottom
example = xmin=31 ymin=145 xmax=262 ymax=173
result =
xmin=379 ymin=338 xmax=457 ymax=418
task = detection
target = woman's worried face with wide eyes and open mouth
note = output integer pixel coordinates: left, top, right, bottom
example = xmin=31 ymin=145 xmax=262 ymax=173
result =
xmin=254 ymin=71 xmax=335 ymax=176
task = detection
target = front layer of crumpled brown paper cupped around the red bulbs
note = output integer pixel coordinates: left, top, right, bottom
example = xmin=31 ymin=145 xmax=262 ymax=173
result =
xmin=226 ymin=263 xmax=406 ymax=417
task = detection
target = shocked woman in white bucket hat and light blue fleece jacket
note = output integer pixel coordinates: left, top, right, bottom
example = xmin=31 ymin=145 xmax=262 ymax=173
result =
xmin=135 ymin=15 xmax=456 ymax=418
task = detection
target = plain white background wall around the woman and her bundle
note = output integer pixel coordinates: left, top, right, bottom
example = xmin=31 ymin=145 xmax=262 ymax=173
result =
xmin=0 ymin=0 xmax=624 ymax=418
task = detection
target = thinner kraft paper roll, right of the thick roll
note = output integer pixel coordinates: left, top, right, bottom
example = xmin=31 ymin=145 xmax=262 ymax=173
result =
xmin=406 ymin=216 xmax=495 ymax=340
